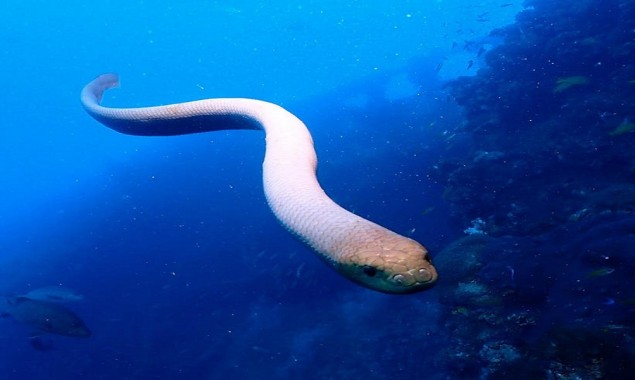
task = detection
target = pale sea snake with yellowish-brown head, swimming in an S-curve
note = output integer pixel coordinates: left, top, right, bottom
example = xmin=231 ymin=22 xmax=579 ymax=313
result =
xmin=81 ymin=74 xmax=437 ymax=294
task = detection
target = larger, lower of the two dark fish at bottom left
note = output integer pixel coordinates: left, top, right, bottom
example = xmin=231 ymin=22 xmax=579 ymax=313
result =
xmin=0 ymin=297 xmax=91 ymax=338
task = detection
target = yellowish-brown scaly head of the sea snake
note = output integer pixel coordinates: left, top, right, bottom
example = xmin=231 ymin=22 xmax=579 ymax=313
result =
xmin=340 ymin=233 xmax=438 ymax=294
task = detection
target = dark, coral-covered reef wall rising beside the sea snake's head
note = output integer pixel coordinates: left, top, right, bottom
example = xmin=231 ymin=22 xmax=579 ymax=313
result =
xmin=430 ymin=0 xmax=635 ymax=379
